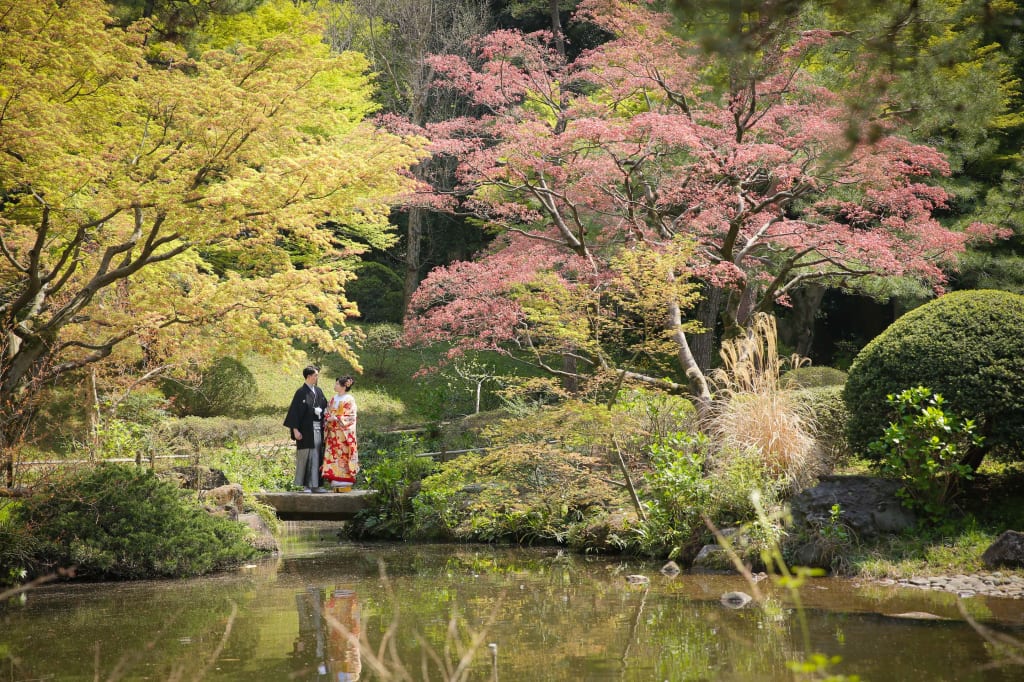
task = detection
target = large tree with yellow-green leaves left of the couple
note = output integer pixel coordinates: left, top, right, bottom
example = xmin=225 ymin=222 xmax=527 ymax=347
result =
xmin=0 ymin=0 xmax=419 ymax=444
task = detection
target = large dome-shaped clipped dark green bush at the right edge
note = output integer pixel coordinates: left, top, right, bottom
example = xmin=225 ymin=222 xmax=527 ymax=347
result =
xmin=843 ymin=290 xmax=1024 ymax=466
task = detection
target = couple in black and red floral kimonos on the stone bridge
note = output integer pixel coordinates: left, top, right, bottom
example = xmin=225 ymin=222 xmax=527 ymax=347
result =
xmin=285 ymin=366 xmax=359 ymax=493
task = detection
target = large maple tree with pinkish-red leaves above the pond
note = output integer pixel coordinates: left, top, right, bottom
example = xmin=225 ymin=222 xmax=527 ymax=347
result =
xmin=409 ymin=0 xmax=1007 ymax=401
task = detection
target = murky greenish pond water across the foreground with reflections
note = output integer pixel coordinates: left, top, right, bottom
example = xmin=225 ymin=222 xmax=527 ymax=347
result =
xmin=0 ymin=524 xmax=1024 ymax=682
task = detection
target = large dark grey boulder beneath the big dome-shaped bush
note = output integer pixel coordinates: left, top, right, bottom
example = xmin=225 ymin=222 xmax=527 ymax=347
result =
xmin=790 ymin=476 xmax=916 ymax=540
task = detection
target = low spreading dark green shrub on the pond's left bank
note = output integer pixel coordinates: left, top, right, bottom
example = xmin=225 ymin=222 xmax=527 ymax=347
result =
xmin=11 ymin=458 xmax=254 ymax=580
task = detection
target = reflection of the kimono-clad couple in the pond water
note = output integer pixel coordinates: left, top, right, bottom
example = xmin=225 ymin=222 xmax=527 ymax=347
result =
xmin=294 ymin=587 xmax=362 ymax=682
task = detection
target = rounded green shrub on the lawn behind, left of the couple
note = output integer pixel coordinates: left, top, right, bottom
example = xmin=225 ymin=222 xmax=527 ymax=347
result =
xmin=161 ymin=357 xmax=256 ymax=417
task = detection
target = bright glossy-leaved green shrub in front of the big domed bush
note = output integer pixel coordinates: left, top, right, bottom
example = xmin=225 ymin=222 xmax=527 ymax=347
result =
xmin=868 ymin=386 xmax=981 ymax=522
